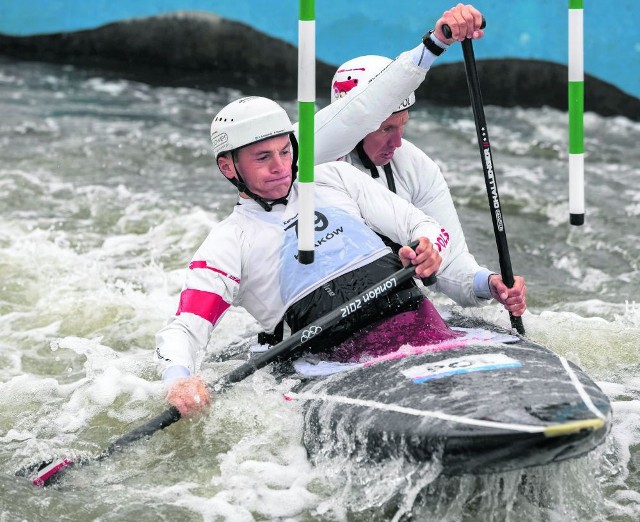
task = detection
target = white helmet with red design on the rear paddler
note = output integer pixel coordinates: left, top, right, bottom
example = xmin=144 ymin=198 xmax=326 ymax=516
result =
xmin=331 ymin=54 xmax=416 ymax=112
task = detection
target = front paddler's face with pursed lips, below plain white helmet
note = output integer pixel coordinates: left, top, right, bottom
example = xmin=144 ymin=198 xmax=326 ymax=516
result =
xmin=218 ymin=135 xmax=292 ymax=200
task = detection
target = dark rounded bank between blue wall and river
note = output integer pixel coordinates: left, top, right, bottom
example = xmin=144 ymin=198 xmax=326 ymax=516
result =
xmin=0 ymin=12 xmax=640 ymax=121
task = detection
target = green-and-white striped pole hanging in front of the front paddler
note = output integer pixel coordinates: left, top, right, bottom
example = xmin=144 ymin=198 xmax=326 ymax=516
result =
xmin=298 ymin=0 xmax=316 ymax=265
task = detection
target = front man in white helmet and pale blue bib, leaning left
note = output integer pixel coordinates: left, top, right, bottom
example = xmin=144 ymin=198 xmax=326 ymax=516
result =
xmin=155 ymin=96 xmax=450 ymax=415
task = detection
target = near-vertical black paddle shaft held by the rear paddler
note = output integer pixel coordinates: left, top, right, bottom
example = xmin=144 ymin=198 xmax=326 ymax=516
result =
xmin=462 ymin=38 xmax=525 ymax=335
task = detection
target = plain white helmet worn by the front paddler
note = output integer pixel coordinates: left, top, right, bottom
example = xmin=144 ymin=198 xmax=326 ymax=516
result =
xmin=211 ymin=96 xmax=293 ymax=159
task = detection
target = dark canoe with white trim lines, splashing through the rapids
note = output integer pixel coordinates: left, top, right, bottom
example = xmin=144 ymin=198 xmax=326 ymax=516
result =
xmin=288 ymin=306 xmax=612 ymax=475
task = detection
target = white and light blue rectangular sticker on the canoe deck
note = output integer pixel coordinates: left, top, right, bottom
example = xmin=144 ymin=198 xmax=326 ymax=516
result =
xmin=402 ymin=353 xmax=522 ymax=384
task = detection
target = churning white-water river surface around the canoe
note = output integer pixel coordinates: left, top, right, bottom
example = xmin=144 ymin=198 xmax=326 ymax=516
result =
xmin=0 ymin=59 xmax=640 ymax=522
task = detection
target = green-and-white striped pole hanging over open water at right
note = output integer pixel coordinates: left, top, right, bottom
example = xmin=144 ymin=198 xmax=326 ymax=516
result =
xmin=569 ymin=0 xmax=584 ymax=226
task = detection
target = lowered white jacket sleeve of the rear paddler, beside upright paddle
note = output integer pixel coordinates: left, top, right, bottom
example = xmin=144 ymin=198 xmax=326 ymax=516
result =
xmin=402 ymin=140 xmax=490 ymax=306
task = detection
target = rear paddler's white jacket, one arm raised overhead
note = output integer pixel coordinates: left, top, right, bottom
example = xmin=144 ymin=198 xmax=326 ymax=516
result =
xmin=304 ymin=44 xmax=495 ymax=306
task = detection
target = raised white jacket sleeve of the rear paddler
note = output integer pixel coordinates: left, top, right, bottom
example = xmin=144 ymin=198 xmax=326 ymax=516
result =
xmin=294 ymin=48 xmax=430 ymax=165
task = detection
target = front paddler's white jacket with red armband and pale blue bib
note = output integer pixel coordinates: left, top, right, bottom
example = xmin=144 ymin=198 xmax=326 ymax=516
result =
xmin=156 ymin=162 xmax=450 ymax=377
